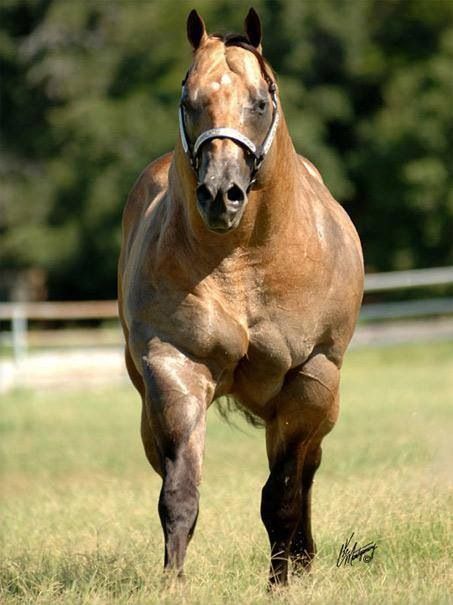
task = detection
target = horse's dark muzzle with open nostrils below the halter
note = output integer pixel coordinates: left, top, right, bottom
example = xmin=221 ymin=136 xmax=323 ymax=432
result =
xmin=197 ymin=183 xmax=247 ymax=233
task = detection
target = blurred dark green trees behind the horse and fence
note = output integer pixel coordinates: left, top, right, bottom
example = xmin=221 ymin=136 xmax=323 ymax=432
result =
xmin=0 ymin=0 xmax=453 ymax=298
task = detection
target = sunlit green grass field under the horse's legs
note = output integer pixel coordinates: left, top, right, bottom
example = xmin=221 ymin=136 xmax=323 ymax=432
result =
xmin=0 ymin=343 xmax=453 ymax=605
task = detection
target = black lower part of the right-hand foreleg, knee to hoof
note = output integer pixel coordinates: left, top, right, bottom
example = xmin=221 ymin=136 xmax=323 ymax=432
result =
xmin=261 ymin=453 xmax=301 ymax=586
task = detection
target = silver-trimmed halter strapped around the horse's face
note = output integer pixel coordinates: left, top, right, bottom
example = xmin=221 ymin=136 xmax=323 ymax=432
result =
xmin=179 ymin=73 xmax=280 ymax=189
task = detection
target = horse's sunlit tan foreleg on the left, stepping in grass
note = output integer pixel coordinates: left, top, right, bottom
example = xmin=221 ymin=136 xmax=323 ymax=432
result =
xmin=142 ymin=344 xmax=213 ymax=576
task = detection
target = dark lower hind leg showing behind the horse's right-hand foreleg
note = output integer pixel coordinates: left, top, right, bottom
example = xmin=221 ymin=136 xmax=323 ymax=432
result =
xmin=290 ymin=445 xmax=322 ymax=573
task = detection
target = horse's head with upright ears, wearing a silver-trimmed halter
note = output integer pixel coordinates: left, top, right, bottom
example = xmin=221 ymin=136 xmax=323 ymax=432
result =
xmin=180 ymin=9 xmax=279 ymax=233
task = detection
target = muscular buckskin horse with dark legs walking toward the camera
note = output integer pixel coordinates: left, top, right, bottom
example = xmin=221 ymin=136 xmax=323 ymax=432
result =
xmin=118 ymin=9 xmax=363 ymax=587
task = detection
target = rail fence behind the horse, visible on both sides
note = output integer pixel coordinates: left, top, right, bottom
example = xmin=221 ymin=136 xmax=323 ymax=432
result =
xmin=0 ymin=267 xmax=453 ymax=361
